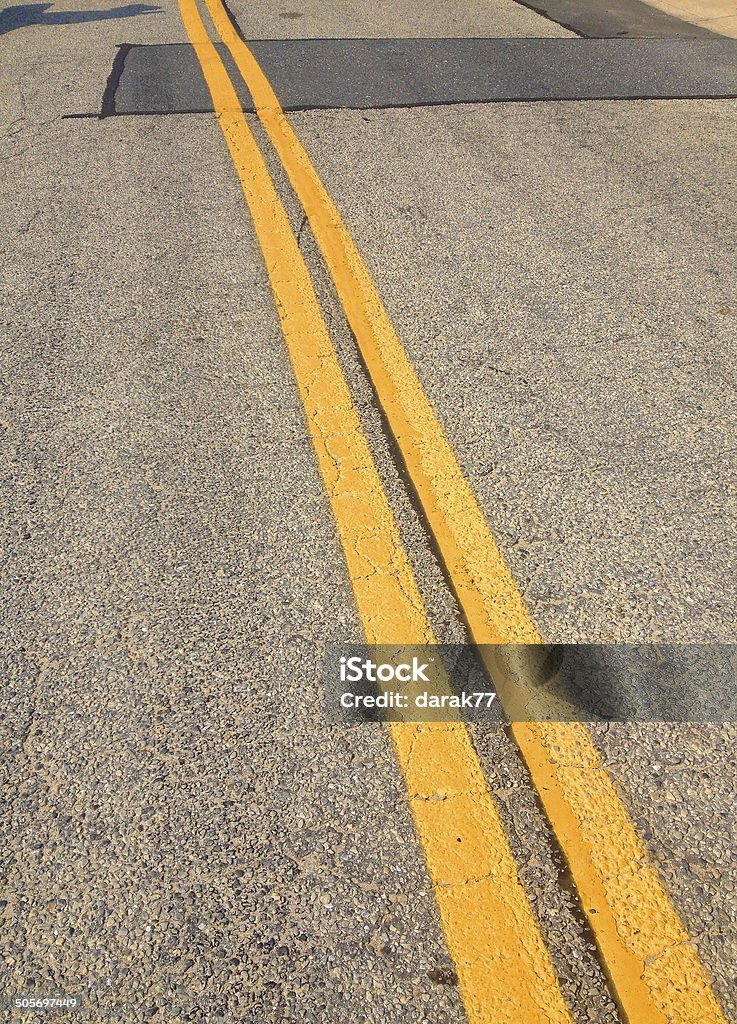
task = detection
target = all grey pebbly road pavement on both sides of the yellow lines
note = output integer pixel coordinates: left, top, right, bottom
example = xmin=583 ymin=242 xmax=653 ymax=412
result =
xmin=0 ymin=0 xmax=737 ymax=1024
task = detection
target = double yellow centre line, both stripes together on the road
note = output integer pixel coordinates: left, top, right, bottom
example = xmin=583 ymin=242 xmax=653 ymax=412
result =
xmin=179 ymin=0 xmax=726 ymax=1024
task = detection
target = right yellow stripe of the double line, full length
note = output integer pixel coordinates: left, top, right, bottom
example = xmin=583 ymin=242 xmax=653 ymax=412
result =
xmin=194 ymin=0 xmax=726 ymax=1024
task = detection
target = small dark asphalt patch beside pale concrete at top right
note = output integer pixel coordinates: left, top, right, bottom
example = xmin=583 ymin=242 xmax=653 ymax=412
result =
xmin=516 ymin=0 xmax=716 ymax=39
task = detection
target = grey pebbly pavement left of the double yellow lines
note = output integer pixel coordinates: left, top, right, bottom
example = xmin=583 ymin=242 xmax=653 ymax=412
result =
xmin=0 ymin=6 xmax=462 ymax=1024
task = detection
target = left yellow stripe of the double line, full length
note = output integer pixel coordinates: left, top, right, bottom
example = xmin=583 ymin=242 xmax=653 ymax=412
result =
xmin=179 ymin=0 xmax=571 ymax=1024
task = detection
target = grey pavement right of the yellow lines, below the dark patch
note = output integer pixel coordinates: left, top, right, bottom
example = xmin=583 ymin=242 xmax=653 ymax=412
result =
xmin=294 ymin=94 xmax=737 ymax=1015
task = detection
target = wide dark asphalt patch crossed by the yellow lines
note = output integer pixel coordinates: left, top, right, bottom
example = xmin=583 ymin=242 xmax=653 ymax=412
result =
xmin=106 ymin=38 xmax=737 ymax=114
